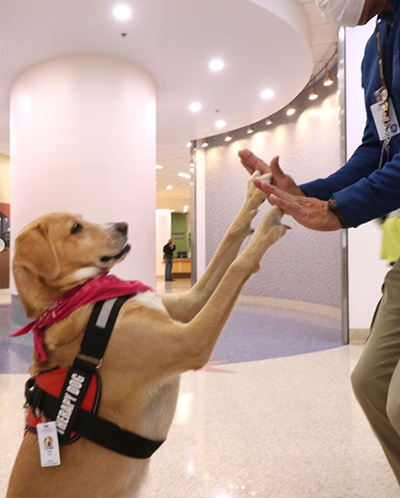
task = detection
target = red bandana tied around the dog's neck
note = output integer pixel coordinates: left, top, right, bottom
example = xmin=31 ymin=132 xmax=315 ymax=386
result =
xmin=10 ymin=273 xmax=152 ymax=361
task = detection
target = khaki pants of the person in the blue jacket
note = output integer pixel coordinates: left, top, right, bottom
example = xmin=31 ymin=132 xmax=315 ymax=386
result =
xmin=351 ymin=259 xmax=400 ymax=483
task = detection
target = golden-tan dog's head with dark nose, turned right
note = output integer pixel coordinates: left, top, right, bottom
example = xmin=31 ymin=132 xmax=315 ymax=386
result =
xmin=13 ymin=213 xmax=130 ymax=318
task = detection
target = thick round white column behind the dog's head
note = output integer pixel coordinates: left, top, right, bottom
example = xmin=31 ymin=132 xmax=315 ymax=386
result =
xmin=10 ymin=56 xmax=156 ymax=294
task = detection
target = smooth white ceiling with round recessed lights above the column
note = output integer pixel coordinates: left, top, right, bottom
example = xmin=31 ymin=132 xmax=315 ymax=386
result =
xmin=0 ymin=0 xmax=337 ymax=211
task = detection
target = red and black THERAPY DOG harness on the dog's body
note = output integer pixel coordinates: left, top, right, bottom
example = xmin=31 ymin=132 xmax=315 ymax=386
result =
xmin=12 ymin=274 xmax=164 ymax=459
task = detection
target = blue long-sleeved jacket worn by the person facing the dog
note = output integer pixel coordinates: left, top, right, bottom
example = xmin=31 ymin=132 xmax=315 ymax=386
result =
xmin=300 ymin=0 xmax=400 ymax=227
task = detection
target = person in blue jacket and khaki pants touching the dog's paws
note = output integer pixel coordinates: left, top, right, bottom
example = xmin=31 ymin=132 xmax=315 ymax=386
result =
xmin=239 ymin=0 xmax=400 ymax=483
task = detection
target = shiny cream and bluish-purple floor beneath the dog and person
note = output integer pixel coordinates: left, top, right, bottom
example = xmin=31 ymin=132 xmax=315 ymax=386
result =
xmin=0 ymin=279 xmax=400 ymax=498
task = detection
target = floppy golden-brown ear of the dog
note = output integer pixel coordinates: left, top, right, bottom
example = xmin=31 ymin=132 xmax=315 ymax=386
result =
xmin=13 ymin=224 xmax=60 ymax=285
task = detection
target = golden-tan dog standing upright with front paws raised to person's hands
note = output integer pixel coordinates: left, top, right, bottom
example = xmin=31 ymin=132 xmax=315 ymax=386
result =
xmin=7 ymin=173 xmax=286 ymax=498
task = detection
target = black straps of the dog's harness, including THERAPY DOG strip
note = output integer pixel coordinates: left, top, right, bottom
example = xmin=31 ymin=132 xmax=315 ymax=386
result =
xmin=25 ymin=296 xmax=164 ymax=459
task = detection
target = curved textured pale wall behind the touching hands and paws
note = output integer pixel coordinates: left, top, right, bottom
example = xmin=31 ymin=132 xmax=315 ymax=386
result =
xmin=198 ymin=77 xmax=341 ymax=309
